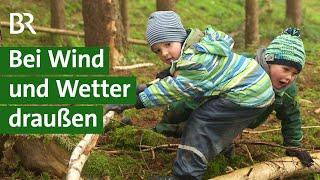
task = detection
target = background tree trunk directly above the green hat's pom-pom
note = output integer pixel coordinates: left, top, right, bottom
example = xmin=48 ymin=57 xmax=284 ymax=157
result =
xmin=286 ymin=0 xmax=302 ymax=26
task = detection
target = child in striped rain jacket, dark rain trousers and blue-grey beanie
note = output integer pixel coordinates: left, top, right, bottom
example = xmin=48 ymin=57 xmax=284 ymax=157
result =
xmin=108 ymin=11 xmax=274 ymax=179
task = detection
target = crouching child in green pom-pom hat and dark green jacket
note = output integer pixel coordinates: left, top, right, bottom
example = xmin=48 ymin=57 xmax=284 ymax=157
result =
xmin=155 ymin=28 xmax=313 ymax=177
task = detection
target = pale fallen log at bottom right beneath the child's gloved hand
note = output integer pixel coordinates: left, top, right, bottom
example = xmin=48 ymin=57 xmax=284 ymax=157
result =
xmin=211 ymin=153 xmax=320 ymax=180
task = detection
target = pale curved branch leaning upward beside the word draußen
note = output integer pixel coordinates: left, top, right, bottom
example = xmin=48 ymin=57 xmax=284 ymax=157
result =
xmin=66 ymin=111 xmax=114 ymax=180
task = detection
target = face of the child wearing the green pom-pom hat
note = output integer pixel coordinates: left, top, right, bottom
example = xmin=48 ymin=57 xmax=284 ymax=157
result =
xmin=269 ymin=64 xmax=299 ymax=90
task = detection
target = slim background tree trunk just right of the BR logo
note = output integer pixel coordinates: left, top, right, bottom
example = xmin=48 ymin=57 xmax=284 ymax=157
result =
xmin=50 ymin=0 xmax=67 ymax=46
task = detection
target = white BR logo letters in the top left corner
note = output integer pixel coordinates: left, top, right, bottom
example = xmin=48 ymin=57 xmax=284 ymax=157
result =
xmin=10 ymin=13 xmax=36 ymax=34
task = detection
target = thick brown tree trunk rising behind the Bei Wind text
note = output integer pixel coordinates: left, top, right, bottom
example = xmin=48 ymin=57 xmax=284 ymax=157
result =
xmin=82 ymin=0 xmax=127 ymax=67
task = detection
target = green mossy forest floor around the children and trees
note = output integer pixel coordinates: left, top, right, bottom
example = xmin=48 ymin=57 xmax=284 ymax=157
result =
xmin=0 ymin=0 xmax=320 ymax=180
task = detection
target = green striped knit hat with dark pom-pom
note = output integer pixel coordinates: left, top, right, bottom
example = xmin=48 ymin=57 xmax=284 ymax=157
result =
xmin=265 ymin=27 xmax=306 ymax=72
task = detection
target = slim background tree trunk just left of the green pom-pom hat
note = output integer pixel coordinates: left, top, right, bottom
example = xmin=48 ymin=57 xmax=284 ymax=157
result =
xmin=245 ymin=0 xmax=259 ymax=47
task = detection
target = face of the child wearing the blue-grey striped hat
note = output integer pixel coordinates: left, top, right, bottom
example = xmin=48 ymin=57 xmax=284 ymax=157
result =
xmin=151 ymin=42 xmax=181 ymax=64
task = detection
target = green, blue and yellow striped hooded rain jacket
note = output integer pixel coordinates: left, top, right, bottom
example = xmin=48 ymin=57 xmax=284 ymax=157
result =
xmin=139 ymin=26 xmax=274 ymax=108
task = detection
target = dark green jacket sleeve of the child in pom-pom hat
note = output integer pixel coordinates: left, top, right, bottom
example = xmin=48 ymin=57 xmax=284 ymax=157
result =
xmin=275 ymin=83 xmax=303 ymax=146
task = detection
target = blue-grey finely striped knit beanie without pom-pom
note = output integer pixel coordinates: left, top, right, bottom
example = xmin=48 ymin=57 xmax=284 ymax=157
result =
xmin=146 ymin=11 xmax=187 ymax=46
